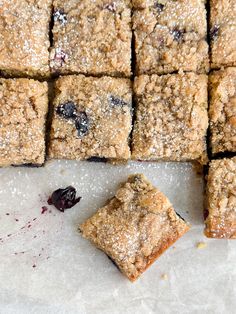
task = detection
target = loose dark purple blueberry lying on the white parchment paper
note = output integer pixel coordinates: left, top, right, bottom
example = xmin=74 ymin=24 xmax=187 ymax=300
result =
xmin=48 ymin=186 xmax=81 ymax=212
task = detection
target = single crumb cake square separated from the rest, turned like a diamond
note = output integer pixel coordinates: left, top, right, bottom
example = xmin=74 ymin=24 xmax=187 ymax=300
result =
xmin=79 ymin=174 xmax=189 ymax=281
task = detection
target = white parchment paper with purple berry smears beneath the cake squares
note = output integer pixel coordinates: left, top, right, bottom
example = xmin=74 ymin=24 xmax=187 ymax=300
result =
xmin=0 ymin=161 xmax=236 ymax=314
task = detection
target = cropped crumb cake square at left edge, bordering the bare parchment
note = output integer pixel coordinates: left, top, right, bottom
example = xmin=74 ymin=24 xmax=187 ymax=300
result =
xmin=0 ymin=78 xmax=48 ymax=167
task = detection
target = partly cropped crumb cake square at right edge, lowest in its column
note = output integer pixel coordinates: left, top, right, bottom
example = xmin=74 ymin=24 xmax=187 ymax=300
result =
xmin=205 ymin=157 xmax=236 ymax=239
